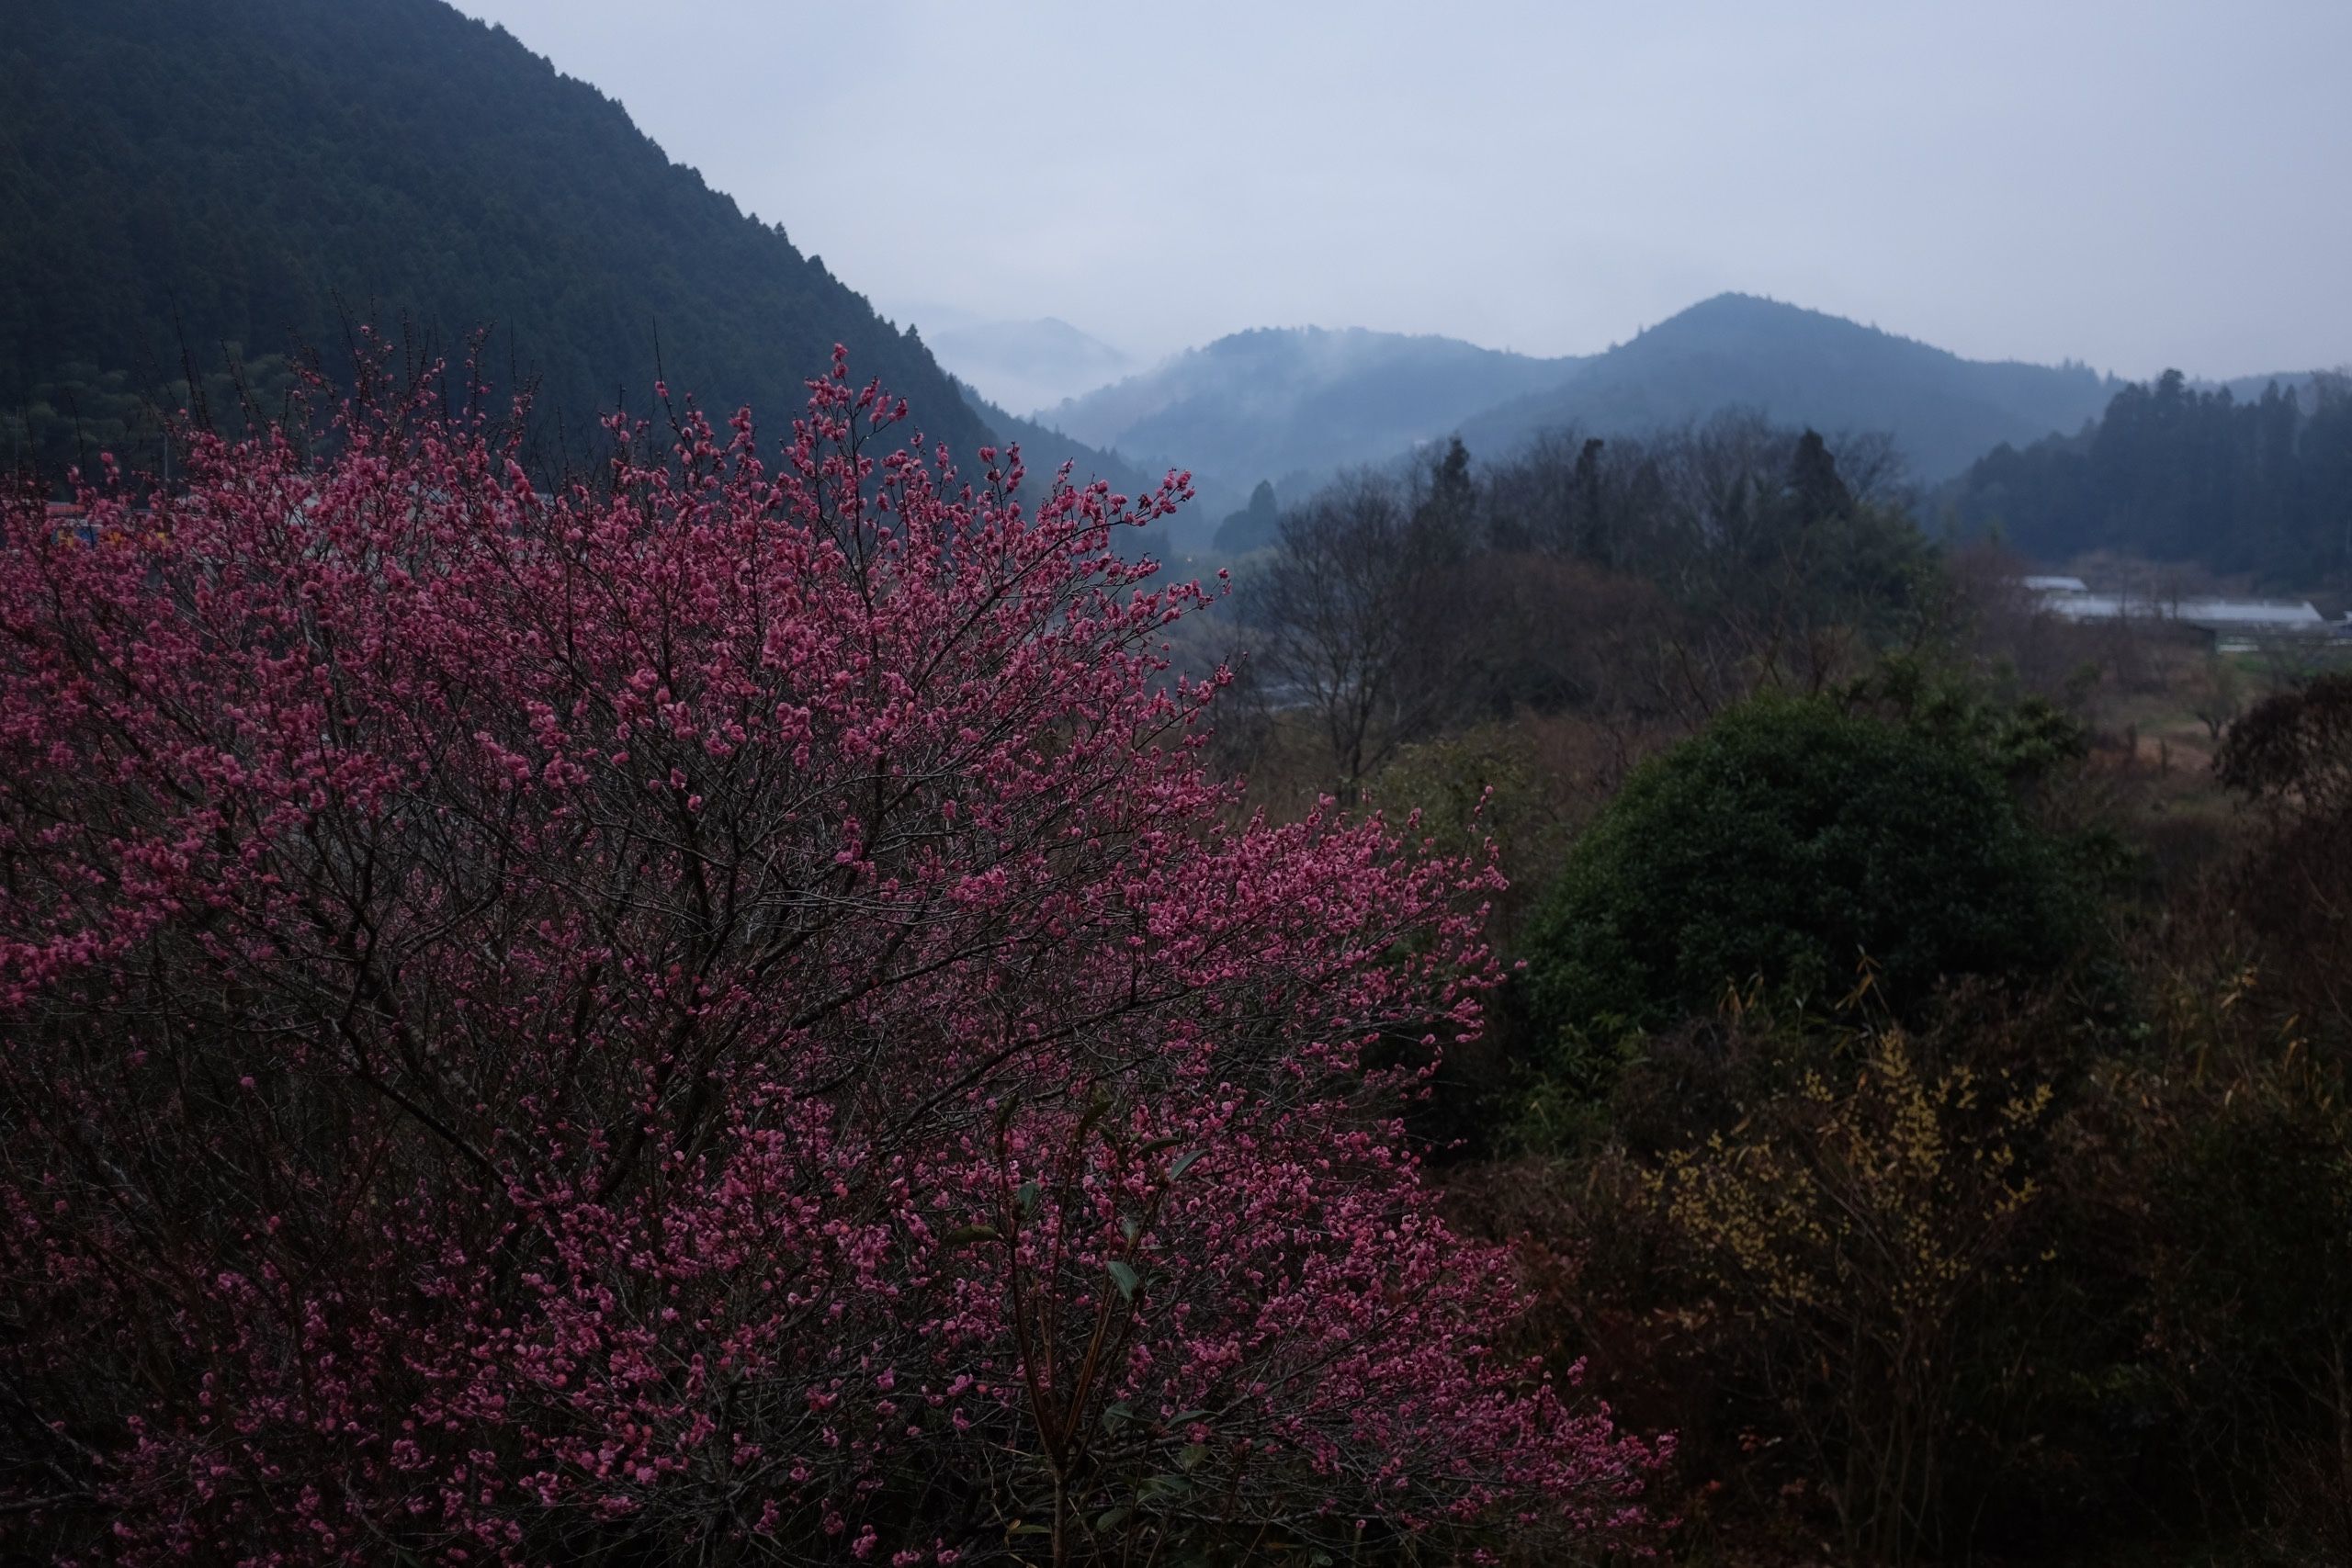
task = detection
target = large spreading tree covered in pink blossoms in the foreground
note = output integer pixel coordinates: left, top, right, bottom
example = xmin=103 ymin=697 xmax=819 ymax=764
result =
xmin=0 ymin=360 xmax=1660 ymax=1563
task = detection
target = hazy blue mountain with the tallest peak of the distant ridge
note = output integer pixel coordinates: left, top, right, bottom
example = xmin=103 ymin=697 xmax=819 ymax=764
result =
xmin=1461 ymin=294 xmax=2120 ymax=482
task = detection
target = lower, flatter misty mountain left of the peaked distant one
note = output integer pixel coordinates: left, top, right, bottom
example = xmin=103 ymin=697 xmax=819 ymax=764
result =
xmin=1037 ymin=327 xmax=1576 ymax=510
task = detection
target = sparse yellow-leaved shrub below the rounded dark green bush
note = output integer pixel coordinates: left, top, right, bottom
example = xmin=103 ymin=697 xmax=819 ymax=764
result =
xmin=1654 ymin=1030 xmax=2051 ymax=1561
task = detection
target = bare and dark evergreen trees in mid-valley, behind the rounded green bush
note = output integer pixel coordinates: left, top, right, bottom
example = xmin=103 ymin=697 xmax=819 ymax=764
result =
xmin=1227 ymin=416 xmax=1933 ymax=785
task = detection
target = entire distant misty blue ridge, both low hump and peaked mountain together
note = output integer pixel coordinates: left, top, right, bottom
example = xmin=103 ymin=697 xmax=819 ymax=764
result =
xmin=1037 ymin=294 xmax=2121 ymax=531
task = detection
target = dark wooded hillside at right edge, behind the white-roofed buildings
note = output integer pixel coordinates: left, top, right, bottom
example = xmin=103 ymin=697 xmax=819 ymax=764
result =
xmin=1954 ymin=371 xmax=2352 ymax=588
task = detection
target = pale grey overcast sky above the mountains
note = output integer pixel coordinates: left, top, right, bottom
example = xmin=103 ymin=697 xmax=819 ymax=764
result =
xmin=458 ymin=0 xmax=2352 ymax=376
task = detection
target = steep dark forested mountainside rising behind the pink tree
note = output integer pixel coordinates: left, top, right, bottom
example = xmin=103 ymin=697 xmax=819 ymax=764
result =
xmin=0 ymin=0 xmax=986 ymax=479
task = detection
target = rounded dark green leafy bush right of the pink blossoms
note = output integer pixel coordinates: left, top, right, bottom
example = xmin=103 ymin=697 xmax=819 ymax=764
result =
xmin=1521 ymin=698 xmax=2076 ymax=1043
